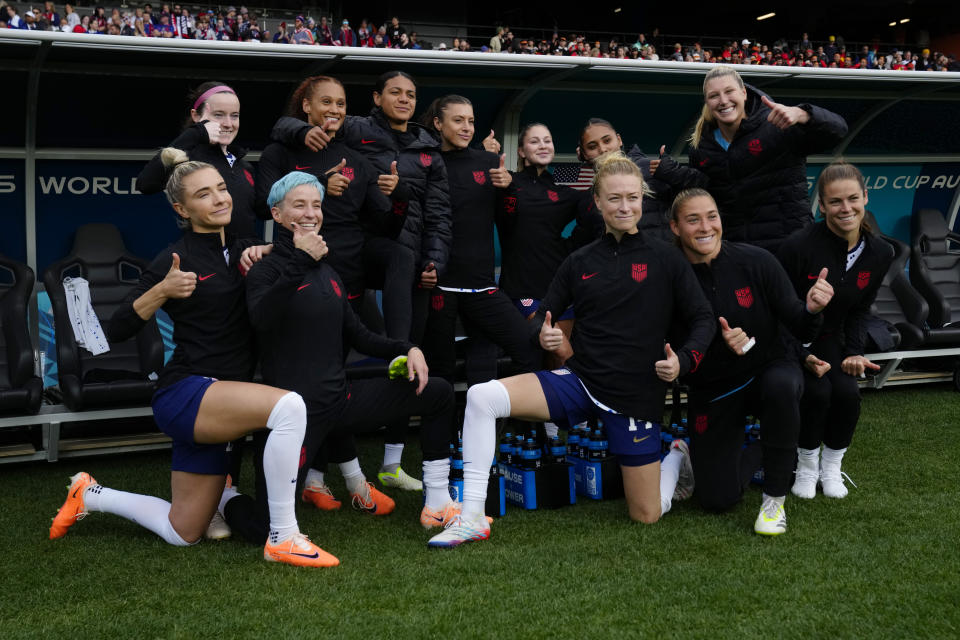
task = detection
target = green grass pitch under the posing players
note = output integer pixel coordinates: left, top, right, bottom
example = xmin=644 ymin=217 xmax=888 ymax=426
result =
xmin=0 ymin=386 xmax=960 ymax=640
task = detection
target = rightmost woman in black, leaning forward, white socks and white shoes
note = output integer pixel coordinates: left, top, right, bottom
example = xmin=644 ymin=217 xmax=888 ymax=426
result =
xmin=779 ymin=163 xmax=893 ymax=498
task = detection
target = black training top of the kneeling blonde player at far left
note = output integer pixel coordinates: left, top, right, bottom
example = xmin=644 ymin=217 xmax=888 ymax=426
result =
xmin=107 ymin=230 xmax=256 ymax=387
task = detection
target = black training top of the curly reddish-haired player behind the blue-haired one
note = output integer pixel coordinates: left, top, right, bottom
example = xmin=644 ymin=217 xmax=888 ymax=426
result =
xmin=256 ymin=137 xmax=407 ymax=293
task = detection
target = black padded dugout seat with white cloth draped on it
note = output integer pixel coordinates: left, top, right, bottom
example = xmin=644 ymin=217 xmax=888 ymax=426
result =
xmin=43 ymin=224 xmax=163 ymax=411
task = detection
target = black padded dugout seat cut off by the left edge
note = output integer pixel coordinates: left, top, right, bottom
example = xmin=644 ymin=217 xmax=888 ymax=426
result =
xmin=0 ymin=255 xmax=43 ymax=413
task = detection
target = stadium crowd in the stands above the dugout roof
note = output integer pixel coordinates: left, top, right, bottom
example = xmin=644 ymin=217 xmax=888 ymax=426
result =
xmin=0 ymin=0 xmax=960 ymax=71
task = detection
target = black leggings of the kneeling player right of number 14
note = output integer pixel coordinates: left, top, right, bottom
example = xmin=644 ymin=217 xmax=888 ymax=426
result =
xmin=688 ymin=360 xmax=803 ymax=511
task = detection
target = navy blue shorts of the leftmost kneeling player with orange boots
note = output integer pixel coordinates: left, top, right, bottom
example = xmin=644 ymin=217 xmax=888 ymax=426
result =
xmin=151 ymin=376 xmax=230 ymax=475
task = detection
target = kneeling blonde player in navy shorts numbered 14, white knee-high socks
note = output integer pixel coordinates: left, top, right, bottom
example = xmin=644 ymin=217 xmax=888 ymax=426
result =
xmin=429 ymin=152 xmax=715 ymax=547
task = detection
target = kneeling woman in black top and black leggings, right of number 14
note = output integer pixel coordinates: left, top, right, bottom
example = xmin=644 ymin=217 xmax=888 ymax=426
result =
xmin=665 ymin=189 xmax=833 ymax=535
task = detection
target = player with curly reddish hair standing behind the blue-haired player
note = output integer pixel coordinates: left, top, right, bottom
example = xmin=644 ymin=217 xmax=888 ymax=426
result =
xmin=257 ymin=76 xmax=410 ymax=312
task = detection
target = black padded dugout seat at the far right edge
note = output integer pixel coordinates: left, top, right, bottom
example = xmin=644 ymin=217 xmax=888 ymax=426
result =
xmin=910 ymin=209 xmax=960 ymax=346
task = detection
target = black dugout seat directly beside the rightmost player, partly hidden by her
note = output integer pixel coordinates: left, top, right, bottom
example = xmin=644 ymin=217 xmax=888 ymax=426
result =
xmin=867 ymin=216 xmax=929 ymax=351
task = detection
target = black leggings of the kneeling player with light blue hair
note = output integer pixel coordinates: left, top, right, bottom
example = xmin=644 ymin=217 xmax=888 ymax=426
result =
xmin=223 ymin=378 xmax=453 ymax=544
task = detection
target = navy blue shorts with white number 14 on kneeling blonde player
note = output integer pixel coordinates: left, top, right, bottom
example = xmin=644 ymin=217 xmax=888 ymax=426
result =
xmin=536 ymin=367 xmax=660 ymax=467
